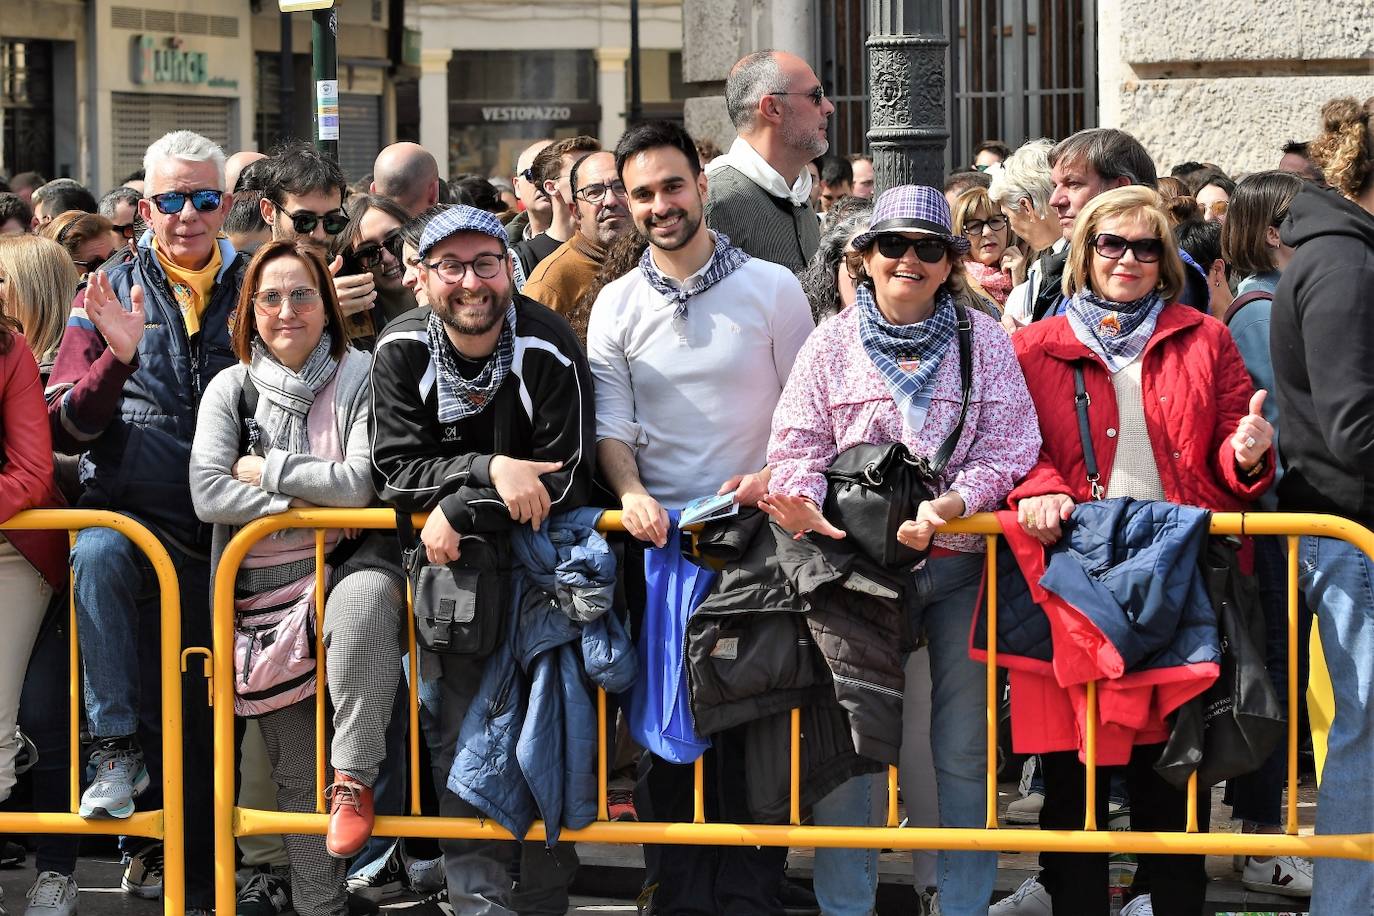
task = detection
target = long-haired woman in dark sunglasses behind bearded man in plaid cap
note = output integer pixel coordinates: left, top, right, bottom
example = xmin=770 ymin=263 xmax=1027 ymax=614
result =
xmin=337 ymin=194 xmax=415 ymax=350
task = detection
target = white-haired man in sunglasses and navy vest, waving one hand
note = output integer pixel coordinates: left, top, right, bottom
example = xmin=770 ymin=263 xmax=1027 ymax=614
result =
xmin=48 ymin=130 xmax=243 ymax=913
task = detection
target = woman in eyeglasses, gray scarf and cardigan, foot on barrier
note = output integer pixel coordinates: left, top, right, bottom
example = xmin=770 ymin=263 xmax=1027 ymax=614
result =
xmin=191 ymin=240 xmax=405 ymax=916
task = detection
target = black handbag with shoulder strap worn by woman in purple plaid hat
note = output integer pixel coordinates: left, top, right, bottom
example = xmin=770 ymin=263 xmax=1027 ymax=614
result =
xmin=823 ymin=299 xmax=973 ymax=569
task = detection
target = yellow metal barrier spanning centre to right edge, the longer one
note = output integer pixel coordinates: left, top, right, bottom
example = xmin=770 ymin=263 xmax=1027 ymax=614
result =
xmin=214 ymin=509 xmax=1374 ymax=912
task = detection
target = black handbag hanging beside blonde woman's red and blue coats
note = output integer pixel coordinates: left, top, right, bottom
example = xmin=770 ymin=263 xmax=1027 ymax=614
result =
xmin=1154 ymin=537 xmax=1287 ymax=788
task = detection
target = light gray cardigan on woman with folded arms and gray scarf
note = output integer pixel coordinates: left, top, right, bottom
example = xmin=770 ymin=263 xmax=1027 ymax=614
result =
xmin=191 ymin=347 xmax=376 ymax=570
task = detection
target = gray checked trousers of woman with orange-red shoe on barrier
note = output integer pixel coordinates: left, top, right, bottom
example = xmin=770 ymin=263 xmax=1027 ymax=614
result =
xmin=258 ymin=567 xmax=405 ymax=916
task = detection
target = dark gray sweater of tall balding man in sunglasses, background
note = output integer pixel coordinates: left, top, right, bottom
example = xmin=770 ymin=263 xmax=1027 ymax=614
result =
xmin=706 ymin=166 xmax=820 ymax=273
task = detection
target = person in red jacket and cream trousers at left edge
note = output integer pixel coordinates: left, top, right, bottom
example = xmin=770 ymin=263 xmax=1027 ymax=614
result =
xmin=0 ymin=311 xmax=66 ymax=801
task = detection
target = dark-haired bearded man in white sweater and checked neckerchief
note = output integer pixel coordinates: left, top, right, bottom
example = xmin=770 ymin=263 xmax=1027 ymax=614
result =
xmin=587 ymin=124 xmax=812 ymax=916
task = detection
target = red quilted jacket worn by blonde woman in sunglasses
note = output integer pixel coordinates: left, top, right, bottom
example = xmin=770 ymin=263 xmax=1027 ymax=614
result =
xmin=1007 ymin=302 xmax=1274 ymax=512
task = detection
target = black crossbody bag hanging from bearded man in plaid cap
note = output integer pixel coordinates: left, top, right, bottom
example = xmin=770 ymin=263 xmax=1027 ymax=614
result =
xmin=396 ymin=512 xmax=511 ymax=658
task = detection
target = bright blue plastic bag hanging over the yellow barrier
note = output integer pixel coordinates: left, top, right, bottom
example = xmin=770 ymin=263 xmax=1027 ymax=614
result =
xmin=624 ymin=512 xmax=716 ymax=764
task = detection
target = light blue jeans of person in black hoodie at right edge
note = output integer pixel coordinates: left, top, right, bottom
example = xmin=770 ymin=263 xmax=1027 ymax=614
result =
xmin=1298 ymin=537 xmax=1374 ymax=916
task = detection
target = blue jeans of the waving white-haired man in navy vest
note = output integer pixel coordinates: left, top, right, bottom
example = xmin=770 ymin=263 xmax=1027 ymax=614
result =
xmin=71 ymin=527 xmax=214 ymax=908
